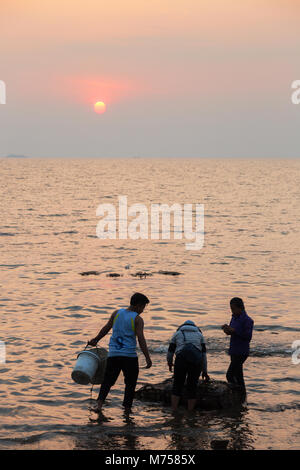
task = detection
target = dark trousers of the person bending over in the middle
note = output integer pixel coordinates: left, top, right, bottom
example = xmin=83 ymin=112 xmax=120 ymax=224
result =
xmin=172 ymin=355 xmax=202 ymax=399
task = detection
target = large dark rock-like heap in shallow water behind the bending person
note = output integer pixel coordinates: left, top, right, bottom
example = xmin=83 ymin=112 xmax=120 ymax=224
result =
xmin=135 ymin=378 xmax=243 ymax=410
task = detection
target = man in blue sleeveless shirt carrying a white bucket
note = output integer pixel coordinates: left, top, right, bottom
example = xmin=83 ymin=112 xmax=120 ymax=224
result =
xmin=88 ymin=293 xmax=152 ymax=413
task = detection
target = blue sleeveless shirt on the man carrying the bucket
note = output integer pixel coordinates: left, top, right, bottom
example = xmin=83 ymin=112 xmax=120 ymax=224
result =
xmin=108 ymin=308 xmax=137 ymax=357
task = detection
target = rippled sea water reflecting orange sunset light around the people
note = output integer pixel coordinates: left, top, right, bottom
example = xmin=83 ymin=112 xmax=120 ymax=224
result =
xmin=0 ymin=158 xmax=300 ymax=449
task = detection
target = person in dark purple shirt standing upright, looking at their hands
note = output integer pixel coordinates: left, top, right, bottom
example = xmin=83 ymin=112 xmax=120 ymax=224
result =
xmin=222 ymin=297 xmax=254 ymax=399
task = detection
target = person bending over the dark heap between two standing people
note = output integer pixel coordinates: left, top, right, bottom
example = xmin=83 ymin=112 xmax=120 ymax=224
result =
xmin=167 ymin=320 xmax=209 ymax=411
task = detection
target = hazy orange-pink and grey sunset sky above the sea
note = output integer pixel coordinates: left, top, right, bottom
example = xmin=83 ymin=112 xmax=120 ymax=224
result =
xmin=0 ymin=0 xmax=300 ymax=158
